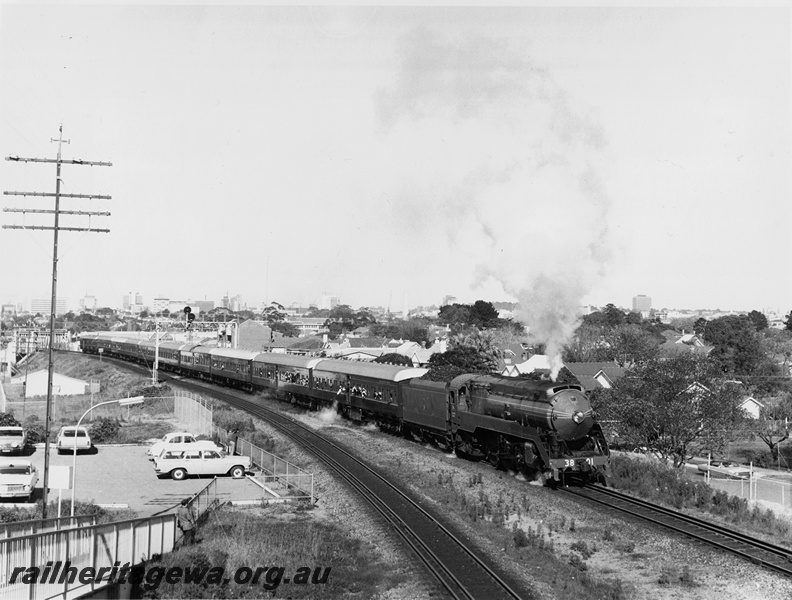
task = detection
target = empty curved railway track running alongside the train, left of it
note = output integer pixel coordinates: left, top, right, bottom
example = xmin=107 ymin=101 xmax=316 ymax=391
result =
xmin=173 ymin=380 xmax=533 ymax=600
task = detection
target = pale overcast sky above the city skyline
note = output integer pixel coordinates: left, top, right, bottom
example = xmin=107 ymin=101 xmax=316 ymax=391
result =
xmin=0 ymin=2 xmax=792 ymax=324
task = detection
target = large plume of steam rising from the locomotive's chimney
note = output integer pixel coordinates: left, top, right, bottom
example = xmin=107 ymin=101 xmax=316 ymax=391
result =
xmin=379 ymin=30 xmax=608 ymax=377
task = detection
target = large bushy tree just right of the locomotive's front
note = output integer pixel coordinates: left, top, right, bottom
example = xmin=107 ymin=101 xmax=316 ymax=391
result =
xmin=597 ymin=354 xmax=743 ymax=467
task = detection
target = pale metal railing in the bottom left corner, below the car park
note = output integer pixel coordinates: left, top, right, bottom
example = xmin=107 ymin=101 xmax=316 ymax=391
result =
xmin=0 ymin=514 xmax=176 ymax=600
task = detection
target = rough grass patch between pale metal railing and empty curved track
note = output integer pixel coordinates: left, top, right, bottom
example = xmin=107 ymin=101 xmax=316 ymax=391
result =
xmin=141 ymin=511 xmax=403 ymax=599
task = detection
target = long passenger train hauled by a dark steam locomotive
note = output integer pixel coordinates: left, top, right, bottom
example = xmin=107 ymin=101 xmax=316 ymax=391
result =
xmin=80 ymin=333 xmax=610 ymax=485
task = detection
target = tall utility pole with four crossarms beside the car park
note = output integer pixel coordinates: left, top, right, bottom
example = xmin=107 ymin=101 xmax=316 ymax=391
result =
xmin=3 ymin=124 xmax=113 ymax=519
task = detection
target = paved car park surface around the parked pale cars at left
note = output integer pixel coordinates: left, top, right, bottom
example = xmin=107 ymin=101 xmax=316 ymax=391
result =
xmin=0 ymin=445 xmax=262 ymax=517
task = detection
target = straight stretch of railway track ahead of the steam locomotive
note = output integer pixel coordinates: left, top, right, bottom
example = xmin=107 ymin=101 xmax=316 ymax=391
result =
xmin=563 ymin=485 xmax=792 ymax=577
